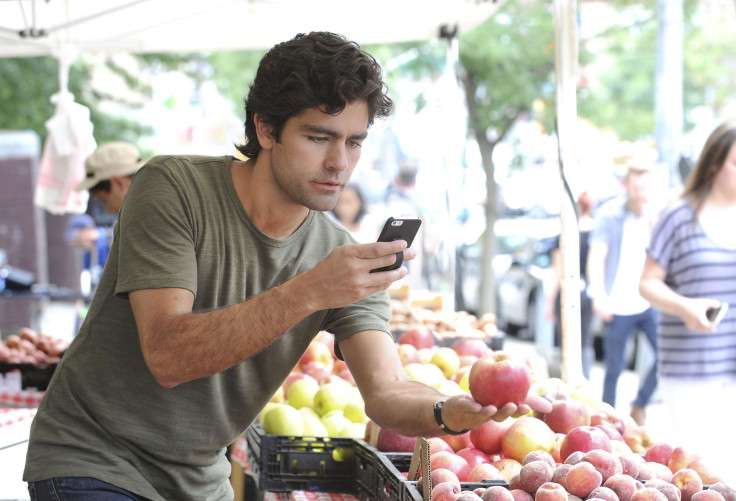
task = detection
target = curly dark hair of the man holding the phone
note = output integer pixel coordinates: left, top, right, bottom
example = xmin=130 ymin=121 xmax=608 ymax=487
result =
xmin=236 ymin=32 xmax=393 ymax=158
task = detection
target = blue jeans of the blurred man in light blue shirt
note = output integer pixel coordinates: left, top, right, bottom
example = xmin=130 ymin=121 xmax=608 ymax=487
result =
xmin=603 ymin=308 xmax=659 ymax=407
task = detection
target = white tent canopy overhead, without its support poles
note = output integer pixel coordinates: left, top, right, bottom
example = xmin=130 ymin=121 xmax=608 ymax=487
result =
xmin=0 ymin=0 xmax=503 ymax=57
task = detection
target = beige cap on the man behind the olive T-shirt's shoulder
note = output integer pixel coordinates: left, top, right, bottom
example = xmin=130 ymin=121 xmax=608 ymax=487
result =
xmin=74 ymin=141 xmax=144 ymax=191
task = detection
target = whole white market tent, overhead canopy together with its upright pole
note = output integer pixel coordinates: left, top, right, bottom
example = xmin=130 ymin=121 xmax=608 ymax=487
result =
xmin=0 ymin=0 xmax=582 ymax=381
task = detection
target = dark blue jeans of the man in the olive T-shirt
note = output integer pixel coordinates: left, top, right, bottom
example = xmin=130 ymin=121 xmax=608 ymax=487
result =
xmin=28 ymin=477 xmax=151 ymax=501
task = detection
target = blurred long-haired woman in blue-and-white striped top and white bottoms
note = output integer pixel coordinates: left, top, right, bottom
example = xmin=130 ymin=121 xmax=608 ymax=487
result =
xmin=640 ymin=121 xmax=736 ymax=481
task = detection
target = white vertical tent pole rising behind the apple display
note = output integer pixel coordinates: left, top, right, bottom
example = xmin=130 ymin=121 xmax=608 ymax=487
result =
xmin=555 ymin=0 xmax=583 ymax=385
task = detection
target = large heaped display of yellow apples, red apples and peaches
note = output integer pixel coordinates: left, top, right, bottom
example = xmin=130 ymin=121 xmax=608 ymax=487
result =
xmin=254 ymin=305 xmax=736 ymax=501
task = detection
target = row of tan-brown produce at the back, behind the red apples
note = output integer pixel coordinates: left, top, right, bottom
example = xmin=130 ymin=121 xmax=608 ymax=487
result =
xmin=389 ymin=299 xmax=499 ymax=339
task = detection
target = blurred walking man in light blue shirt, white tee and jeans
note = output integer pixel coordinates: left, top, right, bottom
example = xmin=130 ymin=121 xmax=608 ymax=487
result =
xmin=587 ymin=157 xmax=659 ymax=425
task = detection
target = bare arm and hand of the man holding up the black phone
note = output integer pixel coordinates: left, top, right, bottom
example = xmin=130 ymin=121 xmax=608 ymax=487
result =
xmin=129 ymin=241 xmax=415 ymax=388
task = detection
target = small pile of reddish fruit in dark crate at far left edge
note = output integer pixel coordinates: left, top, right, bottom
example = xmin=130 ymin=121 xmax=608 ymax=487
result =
xmin=0 ymin=327 xmax=68 ymax=366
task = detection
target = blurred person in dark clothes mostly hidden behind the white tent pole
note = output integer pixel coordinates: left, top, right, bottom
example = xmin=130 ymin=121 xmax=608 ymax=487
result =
xmin=545 ymin=192 xmax=595 ymax=379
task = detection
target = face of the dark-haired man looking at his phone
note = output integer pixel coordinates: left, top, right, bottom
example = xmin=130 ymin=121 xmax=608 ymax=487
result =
xmin=271 ymin=101 xmax=368 ymax=211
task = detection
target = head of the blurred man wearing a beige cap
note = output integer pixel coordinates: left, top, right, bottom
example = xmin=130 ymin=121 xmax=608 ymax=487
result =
xmin=74 ymin=141 xmax=144 ymax=214
